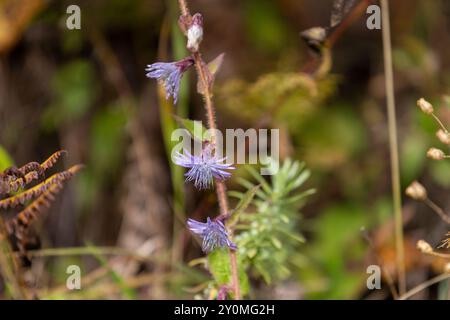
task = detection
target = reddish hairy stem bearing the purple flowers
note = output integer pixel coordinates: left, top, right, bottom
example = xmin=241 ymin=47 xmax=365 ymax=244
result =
xmin=178 ymin=0 xmax=241 ymax=300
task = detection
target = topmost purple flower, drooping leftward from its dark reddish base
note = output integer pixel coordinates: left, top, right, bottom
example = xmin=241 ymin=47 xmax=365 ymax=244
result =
xmin=145 ymin=57 xmax=194 ymax=103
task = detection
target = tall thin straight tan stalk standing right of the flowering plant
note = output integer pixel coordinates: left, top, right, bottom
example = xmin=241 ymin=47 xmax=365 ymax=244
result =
xmin=381 ymin=0 xmax=406 ymax=295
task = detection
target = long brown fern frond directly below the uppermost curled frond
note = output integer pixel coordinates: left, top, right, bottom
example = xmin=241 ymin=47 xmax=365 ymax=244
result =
xmin=0 ymin=165 xmax=82 ymax=209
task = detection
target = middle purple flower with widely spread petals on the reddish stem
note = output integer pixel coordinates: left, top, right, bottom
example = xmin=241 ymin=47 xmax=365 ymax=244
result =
xmin=173 ymin=144 xmax=234 ymax=189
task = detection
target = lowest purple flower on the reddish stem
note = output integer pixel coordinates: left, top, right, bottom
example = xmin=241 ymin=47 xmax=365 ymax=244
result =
xmin=187 ymin=217 xmax=237 ymax=253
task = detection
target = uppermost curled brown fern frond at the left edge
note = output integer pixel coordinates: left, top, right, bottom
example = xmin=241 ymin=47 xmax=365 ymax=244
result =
xmin=0 ymin=150 xmax=67 ymax=194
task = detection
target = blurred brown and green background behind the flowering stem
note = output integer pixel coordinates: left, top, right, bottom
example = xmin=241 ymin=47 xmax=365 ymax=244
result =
xmin=0 ymin=0 xmax=450 ymax=299
